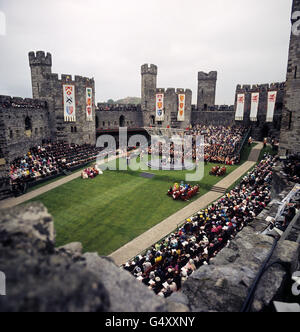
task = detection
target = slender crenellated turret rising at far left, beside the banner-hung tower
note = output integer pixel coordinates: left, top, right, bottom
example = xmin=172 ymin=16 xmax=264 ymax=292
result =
xmin=29 ymin=51 xmax=52 ymax=99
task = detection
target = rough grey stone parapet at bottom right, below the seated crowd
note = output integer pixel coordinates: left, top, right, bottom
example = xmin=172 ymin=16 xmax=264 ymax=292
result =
xmin=171 ymin=215 xmax=299 ymax=312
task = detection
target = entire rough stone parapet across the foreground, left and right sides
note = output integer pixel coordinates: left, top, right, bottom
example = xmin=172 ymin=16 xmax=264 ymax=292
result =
xmin=0 ymin=203 xmax=299 ymax=312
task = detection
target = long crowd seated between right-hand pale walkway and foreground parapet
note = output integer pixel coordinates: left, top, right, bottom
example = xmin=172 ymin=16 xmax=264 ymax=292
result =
xmin=123 ymin=155 xmax=276 ymax=297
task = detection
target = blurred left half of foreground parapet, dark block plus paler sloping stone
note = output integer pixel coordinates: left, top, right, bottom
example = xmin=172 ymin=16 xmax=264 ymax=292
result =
xmin=0 ymin=203 xmax=180 ymax=312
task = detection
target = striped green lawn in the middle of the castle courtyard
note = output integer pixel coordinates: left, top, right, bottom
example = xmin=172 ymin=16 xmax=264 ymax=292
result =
xmin=27 ymin=146 xmax=258 ymax=255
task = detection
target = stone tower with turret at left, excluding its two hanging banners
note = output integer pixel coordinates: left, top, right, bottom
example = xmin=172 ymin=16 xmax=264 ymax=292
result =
xmin=29 ymin=51 xmax=96 ymax=144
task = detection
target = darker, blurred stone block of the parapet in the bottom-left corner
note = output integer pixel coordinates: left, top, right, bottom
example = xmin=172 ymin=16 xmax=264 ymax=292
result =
xmin=0 ymin=203 xmax=110 ymax=312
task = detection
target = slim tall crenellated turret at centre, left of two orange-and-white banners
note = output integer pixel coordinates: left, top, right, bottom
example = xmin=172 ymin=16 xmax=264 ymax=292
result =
xmin=141 ymin=64 xmax=157 ymax=127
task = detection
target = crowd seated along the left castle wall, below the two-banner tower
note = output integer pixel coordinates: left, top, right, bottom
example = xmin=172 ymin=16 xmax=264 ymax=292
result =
xmin=10 ymin=143 xmax=105 ymax=185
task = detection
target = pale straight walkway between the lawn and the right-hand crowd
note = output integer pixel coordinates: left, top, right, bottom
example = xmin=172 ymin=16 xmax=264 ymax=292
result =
xmin=109 ymin=143 xmax=263 ymax=266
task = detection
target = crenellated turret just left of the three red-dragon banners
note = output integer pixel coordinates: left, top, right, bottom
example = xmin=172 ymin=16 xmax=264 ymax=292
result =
xmin=197 ymin=71 xmax=218 ymax=111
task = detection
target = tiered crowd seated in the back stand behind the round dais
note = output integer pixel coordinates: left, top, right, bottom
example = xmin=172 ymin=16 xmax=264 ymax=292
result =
xmin=186 ymin=125 xmax=246 ymax=165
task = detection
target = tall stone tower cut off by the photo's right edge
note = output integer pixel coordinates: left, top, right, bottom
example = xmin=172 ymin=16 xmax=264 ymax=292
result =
xmin=279 ymin=0 xmax=300 ymax=155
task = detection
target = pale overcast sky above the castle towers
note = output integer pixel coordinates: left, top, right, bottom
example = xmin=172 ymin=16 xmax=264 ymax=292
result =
xmin=0 ymin=0 xmax=292 ymax=104
